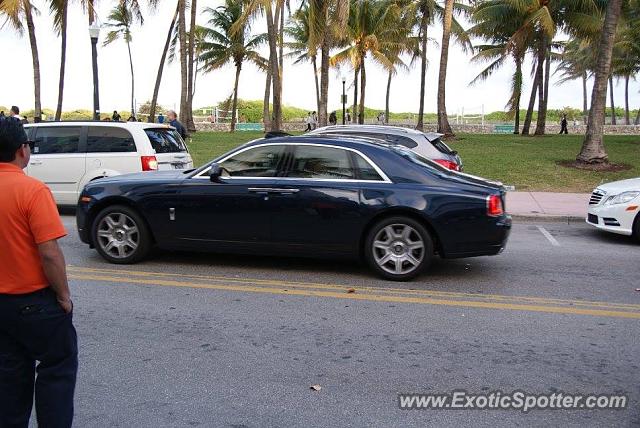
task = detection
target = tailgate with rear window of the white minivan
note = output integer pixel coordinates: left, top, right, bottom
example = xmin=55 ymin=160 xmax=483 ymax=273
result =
xmin=144 ymin=126 xmax=193 ymax=170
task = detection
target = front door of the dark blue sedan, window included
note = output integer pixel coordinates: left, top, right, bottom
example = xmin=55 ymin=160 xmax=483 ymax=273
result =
xmin=174 ymin=144 xmax=286 ymax=249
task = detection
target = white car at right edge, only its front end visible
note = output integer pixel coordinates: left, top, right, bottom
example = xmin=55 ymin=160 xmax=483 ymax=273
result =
xmin=587 ymin=177 xmax=640 ymax=240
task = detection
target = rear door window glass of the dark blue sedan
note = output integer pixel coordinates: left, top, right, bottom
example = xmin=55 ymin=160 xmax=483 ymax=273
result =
xmin=287 ymin=145 xmax=356 ymax=180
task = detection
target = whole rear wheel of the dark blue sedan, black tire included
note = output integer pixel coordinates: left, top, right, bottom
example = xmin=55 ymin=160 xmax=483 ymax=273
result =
xmin=364 ymin=216 xmax=434 ymax=281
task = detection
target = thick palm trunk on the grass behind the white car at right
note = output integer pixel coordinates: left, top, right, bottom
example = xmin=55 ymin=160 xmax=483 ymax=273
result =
xmin=576 ymin=0 xmax=622 ymax=163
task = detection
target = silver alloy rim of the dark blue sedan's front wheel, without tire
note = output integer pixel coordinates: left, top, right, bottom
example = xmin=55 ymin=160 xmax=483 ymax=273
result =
xmin=97 ymin=212 xmax=140 ymax=259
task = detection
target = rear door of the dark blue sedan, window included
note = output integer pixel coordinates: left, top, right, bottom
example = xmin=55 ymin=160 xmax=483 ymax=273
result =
xmin=271 ymin=144 xmax=382 ymax=253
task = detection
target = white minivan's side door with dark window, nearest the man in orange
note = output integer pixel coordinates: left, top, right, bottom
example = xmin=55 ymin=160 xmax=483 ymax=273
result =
xmin=28 ymin=126 xmax=86 ymax=205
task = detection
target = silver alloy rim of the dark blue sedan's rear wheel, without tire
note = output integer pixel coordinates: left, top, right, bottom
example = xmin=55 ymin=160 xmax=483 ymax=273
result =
xmin=373 ymin=224 xmax=425 ymax=275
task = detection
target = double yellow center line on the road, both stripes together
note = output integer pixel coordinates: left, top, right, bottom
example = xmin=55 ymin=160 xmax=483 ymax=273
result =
xmin=68 ymin=266 xmax=640 ymax=319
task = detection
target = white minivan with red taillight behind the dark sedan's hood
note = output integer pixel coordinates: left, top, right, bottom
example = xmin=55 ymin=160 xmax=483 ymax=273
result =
xmin=25 ymin=121 xmax=193 ymax=205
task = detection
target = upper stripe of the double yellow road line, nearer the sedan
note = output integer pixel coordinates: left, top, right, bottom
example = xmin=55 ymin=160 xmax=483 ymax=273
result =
xmin=68 ymin=266 xmax=640 ymax=310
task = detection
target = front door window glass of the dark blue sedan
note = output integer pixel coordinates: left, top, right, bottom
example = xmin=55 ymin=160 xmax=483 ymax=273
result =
xmin=220 ymin=146 xmax=285 ymax=177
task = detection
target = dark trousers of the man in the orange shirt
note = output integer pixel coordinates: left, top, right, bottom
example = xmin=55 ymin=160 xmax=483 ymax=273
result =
xmin=0 ymin=288 xmax=78 ymax=428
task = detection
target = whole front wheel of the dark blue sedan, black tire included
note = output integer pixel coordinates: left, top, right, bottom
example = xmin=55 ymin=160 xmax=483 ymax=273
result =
xmin=91 ymin=205 xmax=153 ymax=264
